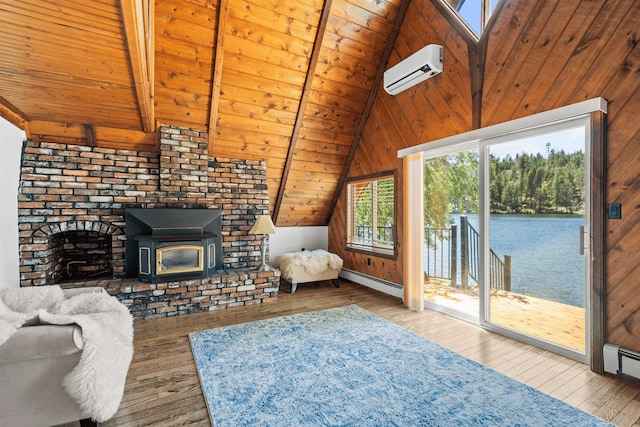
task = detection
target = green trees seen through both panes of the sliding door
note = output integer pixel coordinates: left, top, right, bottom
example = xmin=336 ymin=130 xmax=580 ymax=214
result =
xmin=424 ymin=144 xmax=585 ymax=227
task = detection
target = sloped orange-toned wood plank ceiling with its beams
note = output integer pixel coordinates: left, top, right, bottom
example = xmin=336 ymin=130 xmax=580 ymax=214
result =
xmin=0 ymin=0 xmax=408 ymax=226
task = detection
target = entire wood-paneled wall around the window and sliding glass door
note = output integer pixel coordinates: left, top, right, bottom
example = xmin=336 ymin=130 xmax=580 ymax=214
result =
xmin=329 ymin=0 xmax=640 ymax=351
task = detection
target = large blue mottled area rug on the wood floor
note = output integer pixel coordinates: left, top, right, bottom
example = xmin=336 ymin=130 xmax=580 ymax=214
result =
xmin=189 ymin=305 xmax=611 ymax=427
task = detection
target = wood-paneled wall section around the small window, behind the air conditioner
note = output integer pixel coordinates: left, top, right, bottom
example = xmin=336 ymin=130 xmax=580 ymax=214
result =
xmin=329 ymin=0 xmax=472 ymax=284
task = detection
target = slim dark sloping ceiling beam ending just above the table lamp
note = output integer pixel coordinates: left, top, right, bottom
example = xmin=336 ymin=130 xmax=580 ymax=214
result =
xmin=271 ymin=0 xmax=333 ymax=225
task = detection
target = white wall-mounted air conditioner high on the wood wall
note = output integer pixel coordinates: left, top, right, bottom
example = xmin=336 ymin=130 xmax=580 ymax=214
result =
xmin=384 ymin=44 xmax=442 ymax=95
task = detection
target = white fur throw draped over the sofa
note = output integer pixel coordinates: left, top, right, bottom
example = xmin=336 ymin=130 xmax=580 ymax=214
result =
xmin=0 ymin=286 xmax=133 ymax=422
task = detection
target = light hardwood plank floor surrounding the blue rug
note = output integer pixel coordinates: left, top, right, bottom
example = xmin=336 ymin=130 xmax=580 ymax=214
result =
xmin=101 ymin=281 xmax=640 ymax=427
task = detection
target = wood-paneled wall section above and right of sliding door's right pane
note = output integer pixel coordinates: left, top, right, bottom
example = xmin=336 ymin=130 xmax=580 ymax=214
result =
xmin=481 ymin=0 xmax=640 ymax=351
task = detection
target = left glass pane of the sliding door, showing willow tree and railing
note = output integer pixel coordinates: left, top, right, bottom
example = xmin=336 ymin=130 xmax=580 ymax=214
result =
xmin=423 ymin=150 xmax=480 ymax=318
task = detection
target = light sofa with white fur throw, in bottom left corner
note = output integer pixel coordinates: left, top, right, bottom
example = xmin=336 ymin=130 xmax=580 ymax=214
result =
xmin=0 ymin=286 xmax=133 ymax=426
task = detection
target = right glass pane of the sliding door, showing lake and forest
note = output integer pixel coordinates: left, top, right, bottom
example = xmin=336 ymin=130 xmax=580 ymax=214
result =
xmin=483 ymin=120 xmax=589 ymax=353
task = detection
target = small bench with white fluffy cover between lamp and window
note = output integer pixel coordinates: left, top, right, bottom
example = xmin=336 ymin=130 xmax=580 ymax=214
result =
xmin=271 ymin=249 xmax=342 ymax=293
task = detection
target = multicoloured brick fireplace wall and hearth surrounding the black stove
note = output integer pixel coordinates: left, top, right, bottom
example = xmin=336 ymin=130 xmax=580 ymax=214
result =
xmin=18 ymin=126 xmax=280 ymax=319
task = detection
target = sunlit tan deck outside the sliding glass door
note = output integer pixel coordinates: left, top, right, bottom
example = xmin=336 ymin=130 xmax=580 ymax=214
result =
xmin=424 ymin=282 xmax=586 ymax=352
